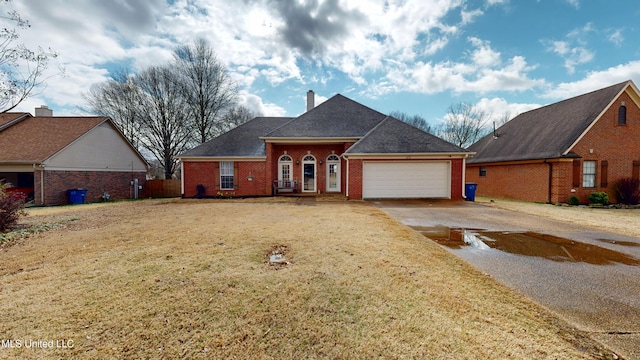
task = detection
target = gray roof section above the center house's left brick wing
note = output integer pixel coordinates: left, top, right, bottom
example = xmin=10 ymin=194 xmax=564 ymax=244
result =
xmin=180 ymin=117 xmax=293 ymax=157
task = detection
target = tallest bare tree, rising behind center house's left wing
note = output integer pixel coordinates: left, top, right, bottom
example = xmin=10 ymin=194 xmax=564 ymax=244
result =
xmin=174 ymin=38 xmax=238 ymax=143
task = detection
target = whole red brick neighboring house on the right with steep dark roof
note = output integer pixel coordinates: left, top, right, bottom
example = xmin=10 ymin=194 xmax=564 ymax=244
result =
xmin=467 ymin=81 xmax=640 ymax=203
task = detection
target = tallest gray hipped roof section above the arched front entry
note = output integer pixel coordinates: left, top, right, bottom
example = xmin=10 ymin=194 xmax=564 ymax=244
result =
xmin=264 ymin=94 xmax=386 ymax=138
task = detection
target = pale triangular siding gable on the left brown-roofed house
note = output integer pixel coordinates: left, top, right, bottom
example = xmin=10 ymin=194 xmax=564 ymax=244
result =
xmin=44 ymin=122 xmax=147 ymax=172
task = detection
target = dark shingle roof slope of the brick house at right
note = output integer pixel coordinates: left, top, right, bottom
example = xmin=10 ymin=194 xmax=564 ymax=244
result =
xmin=468 ymin=81 xmax=631 ymax=163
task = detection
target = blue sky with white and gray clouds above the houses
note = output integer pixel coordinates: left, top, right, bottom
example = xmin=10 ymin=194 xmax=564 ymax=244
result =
xmin=0 ymin=0 xmax=640 ymax=125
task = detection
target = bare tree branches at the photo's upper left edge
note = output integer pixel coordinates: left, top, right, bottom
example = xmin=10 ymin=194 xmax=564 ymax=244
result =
xmin=0 ymin=0 xmax=57 ymax=113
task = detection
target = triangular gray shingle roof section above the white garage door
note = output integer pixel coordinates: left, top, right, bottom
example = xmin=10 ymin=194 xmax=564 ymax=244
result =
xmin=345 ymin=117 xmax=468 ymax=154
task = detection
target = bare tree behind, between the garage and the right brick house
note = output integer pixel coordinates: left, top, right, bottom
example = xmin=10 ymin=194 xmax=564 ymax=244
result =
xmin=436 ymin=102 xmax=490 ymax=148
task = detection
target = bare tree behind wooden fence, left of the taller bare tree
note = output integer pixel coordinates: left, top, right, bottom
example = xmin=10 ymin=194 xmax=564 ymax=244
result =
xmin=134 ymin=66 xmax=192 ymax=179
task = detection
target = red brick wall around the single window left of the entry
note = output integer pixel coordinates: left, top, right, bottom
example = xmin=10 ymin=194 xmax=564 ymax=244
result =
xmin=183 ymin=161 xmax=271 ymax=197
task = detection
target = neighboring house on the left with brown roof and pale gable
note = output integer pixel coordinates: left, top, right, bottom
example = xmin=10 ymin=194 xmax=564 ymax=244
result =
xmin=0 ymin=107 xmax=148 ymax=205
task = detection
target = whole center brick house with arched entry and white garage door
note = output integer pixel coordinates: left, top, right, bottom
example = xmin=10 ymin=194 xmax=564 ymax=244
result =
xmin=179 ymin=91 xmax=471 ymax=199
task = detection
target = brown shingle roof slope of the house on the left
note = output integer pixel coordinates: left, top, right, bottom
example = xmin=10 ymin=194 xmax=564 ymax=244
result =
xmin=0 ymin=116 xmax=108 ymax=163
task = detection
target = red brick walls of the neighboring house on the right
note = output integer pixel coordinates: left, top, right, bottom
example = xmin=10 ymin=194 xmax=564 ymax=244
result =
xmin=467 ymin=89 xmax=640 ymax=203
